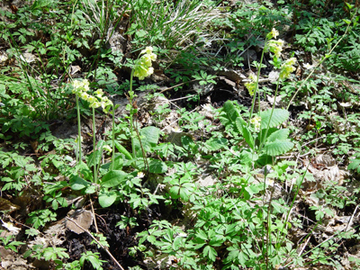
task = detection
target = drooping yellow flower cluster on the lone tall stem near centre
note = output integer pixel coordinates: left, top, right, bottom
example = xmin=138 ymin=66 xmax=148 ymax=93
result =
xmin=134 ymin=47 xmax=156 ymax=80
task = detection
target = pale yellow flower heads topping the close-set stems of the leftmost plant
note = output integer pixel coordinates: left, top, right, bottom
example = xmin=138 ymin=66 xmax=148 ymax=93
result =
xmin=71 ymin=80 xmax=113 ymax=113
